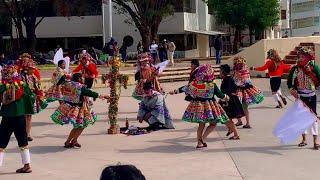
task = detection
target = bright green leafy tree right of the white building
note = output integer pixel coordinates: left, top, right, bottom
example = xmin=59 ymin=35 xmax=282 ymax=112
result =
xmin=206 ymin=0 xmax=280 ymax=52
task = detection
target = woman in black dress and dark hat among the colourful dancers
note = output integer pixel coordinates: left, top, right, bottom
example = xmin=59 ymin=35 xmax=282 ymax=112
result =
xmin=220 ymin=64 xmax=245 ymax=136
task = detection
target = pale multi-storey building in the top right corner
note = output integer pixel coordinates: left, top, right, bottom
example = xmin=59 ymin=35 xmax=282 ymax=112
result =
xmin=282 ymin=0 xmax=320 ymax=37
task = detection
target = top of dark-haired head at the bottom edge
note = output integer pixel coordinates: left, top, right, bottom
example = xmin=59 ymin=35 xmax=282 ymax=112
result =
xmin=100 ymin=165 xmax=146 ymax=180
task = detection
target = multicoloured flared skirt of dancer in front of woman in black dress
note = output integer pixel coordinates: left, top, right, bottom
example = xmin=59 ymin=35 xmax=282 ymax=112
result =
xmin=182 ymin=100 xmax=229 ymax=124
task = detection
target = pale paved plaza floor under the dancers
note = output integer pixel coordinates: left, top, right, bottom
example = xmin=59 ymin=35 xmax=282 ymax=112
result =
xmin=0 ymin=79 xmax=320 ymax=180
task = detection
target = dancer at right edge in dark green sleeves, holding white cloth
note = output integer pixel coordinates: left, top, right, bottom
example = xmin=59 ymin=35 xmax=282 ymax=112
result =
xmin=287 ymin=47 xmax=320 ymax=150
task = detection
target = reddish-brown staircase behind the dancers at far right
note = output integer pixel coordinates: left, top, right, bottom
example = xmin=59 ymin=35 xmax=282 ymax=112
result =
xmin=282 ymin=42 xmax=315 ymax=78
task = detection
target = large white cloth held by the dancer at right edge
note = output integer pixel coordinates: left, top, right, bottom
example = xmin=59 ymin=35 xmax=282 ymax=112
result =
xmin=273 ymin=99 xmax=318 ymax=144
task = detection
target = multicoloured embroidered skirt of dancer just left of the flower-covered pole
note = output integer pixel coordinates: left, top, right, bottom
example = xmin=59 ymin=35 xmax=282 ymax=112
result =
xmin=51 ymin=103 xmax=97 ymax=128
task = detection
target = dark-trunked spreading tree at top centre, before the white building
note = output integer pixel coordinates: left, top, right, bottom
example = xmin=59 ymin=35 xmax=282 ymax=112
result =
xmin=112 ymin=0 xmax=175 ymax=47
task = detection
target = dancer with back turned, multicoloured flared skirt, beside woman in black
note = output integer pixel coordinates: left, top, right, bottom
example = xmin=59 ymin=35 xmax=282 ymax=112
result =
xmin=170 ymin=65 xmax=240 ymax=148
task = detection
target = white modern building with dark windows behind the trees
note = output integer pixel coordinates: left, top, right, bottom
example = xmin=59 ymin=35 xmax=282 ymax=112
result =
xmin=12 ymin=0 xmax=221 ymax=57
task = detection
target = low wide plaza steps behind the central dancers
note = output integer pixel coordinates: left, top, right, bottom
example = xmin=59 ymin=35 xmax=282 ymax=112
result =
xmin=159 ymin=65 xmax=220 ymax=83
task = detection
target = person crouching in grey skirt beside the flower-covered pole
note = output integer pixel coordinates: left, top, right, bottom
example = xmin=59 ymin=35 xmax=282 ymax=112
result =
xmin=137 ymin=83 xmax=174 ymax=131
